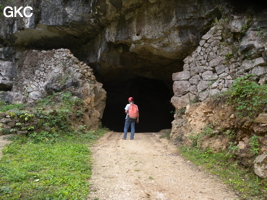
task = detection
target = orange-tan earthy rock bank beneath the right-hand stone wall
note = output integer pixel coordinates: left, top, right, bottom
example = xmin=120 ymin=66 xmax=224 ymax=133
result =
xmin=171 ymin=99 xmax=267 ymax=167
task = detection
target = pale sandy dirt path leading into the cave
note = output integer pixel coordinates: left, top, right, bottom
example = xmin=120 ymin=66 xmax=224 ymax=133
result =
xmin=89 ymin=132 xmax=241 ymax=200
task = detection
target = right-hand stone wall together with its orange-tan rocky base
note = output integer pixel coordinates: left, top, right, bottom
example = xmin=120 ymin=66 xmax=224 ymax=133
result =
xmin=171 ymin=16 xmax=267 ymax=178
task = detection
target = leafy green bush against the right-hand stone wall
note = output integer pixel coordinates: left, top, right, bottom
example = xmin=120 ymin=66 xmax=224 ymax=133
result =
xmin=225 ymin=74 xmax=267 ymax=117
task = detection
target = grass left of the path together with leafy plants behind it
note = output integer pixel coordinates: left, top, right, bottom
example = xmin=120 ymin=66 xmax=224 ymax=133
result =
xmin=0 ymin=92 xmax=107 ymax=200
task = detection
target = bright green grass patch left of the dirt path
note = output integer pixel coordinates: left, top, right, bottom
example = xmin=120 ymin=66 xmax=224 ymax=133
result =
xmin=0 ymin=129 xmax=106 ymax=200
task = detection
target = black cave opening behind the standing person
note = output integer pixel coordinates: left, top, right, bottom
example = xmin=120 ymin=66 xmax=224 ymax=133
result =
xmin=102 ymin=77 xmax=174 ymax=132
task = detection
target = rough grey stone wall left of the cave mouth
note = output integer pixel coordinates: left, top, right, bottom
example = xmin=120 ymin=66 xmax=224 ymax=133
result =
xmin=2 ymin=49 xmax=106 ymax=127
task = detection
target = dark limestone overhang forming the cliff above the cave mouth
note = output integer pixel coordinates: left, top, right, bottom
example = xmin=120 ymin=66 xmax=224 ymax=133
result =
xmin=0 ymin=0 xmax=222 ymax=81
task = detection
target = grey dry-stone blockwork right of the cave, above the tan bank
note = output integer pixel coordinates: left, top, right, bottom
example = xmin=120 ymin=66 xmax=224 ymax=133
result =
xmin=171 ymin=16 xmax=267 ymax=109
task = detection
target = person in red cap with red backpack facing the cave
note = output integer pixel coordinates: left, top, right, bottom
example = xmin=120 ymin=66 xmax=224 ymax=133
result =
xmin=122 ymin=97 xmax=139 ymax=140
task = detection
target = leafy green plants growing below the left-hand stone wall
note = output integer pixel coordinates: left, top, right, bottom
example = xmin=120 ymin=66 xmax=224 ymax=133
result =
xmin=0 ymin=92 xmax=91 ymax=142
